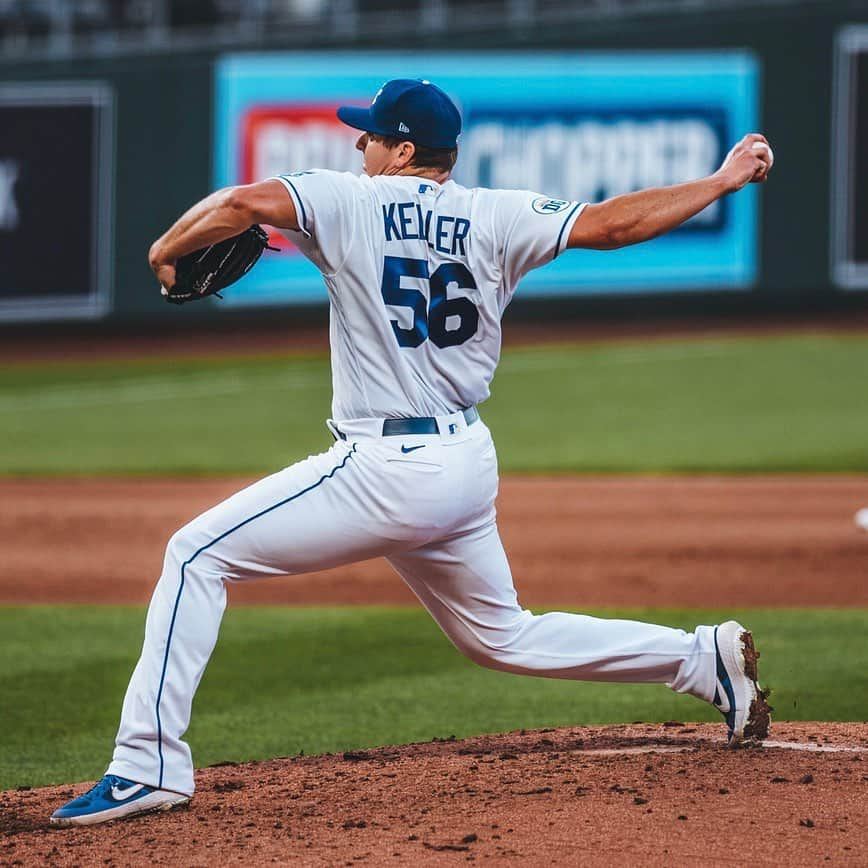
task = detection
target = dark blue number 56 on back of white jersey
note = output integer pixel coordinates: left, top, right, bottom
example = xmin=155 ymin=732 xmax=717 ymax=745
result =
xmin=382 ymin=256 xmax=479 ymax=349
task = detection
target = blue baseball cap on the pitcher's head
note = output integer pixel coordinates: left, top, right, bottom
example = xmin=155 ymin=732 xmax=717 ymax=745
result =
xmin=338 ymin=78 xmax=461 ymax=150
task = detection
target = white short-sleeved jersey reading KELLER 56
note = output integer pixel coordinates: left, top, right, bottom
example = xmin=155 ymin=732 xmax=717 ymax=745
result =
xmin=278 ymin=170 xmax=584 ymax=419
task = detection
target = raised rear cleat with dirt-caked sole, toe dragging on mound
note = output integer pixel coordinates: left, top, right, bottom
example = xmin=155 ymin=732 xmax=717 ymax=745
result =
xmin=712 ymin=621 xmax=772 ymax=747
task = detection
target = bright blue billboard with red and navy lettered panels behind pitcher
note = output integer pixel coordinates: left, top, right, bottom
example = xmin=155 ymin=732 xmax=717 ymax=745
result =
xmin=214 ymin=51 xmax=759 ymax=305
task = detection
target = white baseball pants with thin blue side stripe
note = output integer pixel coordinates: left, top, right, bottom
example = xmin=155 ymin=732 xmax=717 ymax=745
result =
xmin=108 ymin=413 xmax=715 ymax=794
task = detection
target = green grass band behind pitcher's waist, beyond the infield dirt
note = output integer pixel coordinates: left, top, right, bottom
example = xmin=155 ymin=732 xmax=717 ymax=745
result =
xmin=0 ymin=336 xmax=868 ymax=475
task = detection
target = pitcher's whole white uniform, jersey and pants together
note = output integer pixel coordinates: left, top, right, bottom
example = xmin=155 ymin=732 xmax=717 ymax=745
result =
xmin=108 ymin=171 xmax=717 ymax=795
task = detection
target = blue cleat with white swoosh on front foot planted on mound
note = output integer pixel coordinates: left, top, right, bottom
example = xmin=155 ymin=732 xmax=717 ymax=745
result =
xmin=51 ymin=775 xmax=190 ymax=826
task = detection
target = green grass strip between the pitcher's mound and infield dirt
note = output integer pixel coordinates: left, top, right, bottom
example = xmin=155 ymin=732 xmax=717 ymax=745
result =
xmin=0 ymin=606 xmax=868 ymax=789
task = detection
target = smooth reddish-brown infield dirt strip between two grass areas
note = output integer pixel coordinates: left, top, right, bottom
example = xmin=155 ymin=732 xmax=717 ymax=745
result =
xmin=0 ymin=476 xmax=868 ymax=608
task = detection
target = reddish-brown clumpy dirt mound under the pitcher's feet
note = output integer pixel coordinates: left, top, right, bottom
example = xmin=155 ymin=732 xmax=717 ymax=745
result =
xmin=0 ymin=722 xmax=868 ymax=866
